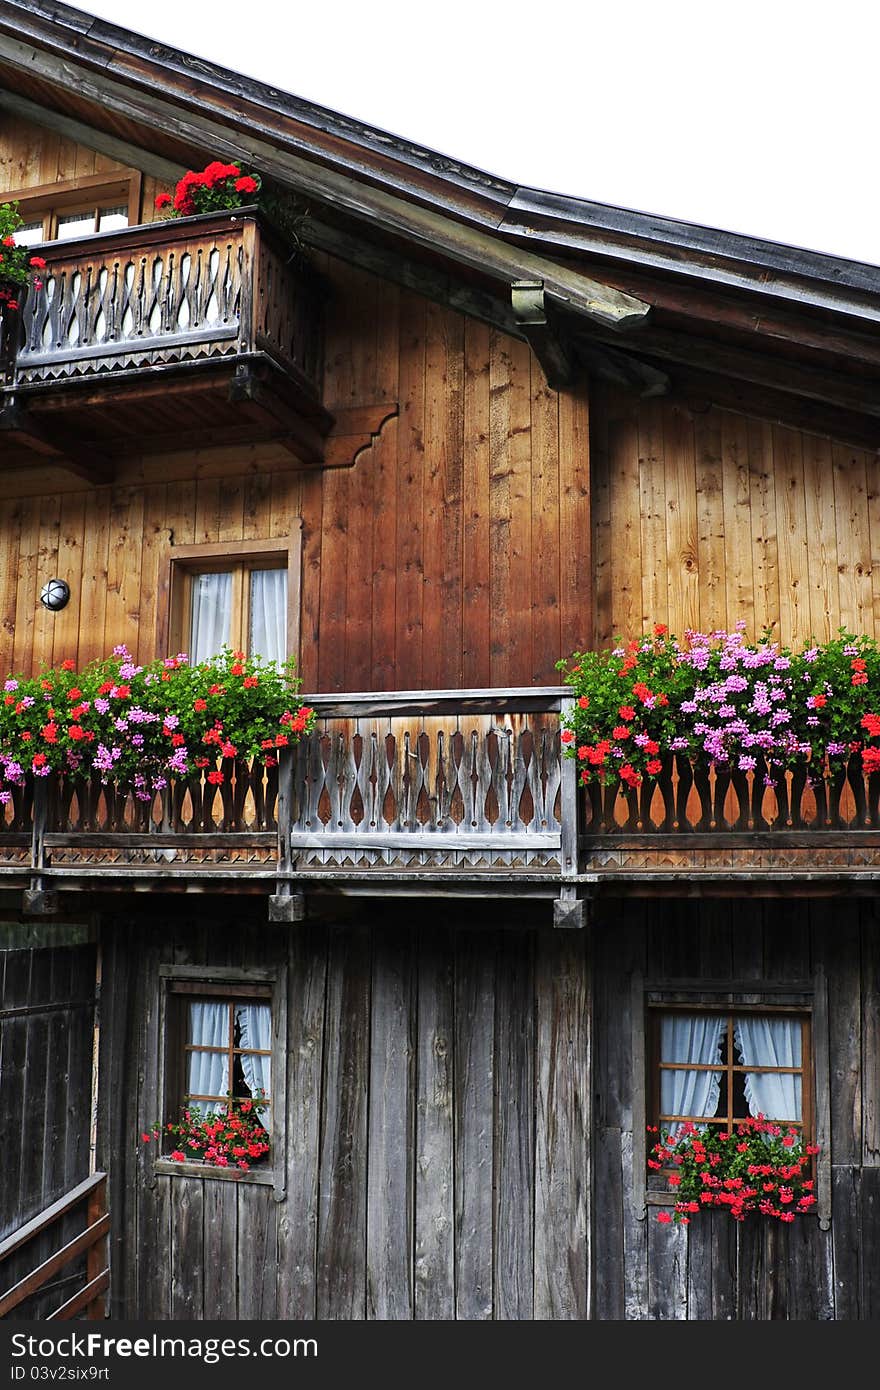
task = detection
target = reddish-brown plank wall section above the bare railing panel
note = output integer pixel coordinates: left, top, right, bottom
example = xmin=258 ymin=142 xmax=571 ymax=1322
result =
xmin=303 ymin=271 xmax=589 ymax=691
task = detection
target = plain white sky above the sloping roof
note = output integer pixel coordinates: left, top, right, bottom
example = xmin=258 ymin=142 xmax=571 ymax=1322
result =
xmin=67 ymin=0 xmax=880 ymax=265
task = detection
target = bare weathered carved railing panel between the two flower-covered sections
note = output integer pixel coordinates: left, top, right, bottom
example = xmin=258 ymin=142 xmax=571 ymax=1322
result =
xmin=292 ymin=695 xmax=562 ymax=873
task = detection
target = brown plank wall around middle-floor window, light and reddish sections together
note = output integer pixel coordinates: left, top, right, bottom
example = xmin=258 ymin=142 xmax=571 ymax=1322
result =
xmin=0 ymin=254 xmax=591 ymax=691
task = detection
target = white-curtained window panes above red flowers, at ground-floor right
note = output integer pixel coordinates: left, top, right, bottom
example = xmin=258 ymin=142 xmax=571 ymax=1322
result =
xmin=649 ymin=1008 xmax=812 ymax=1138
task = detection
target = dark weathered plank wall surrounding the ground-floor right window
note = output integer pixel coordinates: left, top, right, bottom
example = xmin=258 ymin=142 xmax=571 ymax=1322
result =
xmin=594 ymin=899 xmax=880 ymax=1321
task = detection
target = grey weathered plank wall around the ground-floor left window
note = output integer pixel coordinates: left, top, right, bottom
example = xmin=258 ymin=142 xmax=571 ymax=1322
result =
xmin=99 ymin=904 xmax=589 ymax=1321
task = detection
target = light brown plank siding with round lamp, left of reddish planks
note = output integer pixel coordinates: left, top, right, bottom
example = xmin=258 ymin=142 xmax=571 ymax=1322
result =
xmin=0 ymin=449 xmax=300 ymax=673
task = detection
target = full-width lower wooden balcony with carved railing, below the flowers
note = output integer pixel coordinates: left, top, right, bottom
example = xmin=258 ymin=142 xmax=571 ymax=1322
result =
xmin=0 ymin=687 xmax=880 ymax=926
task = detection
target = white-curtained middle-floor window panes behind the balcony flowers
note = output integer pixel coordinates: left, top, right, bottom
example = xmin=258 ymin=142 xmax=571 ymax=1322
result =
xmin=182 ymin=563 xmax=288 ymax=664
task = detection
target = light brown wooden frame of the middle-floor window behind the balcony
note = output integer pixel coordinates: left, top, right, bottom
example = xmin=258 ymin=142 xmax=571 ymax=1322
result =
xmin=156 ymin=527 xmax=302 ymax=670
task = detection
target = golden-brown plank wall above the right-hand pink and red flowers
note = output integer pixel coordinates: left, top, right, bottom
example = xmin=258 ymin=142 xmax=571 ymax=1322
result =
xmin=591 ymin=384 xmax=880 ymax=646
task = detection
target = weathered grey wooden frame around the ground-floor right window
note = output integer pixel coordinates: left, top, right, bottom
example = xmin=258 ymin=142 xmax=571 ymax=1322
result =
xmin=631 ymin=967 xmax=831 ymax=1230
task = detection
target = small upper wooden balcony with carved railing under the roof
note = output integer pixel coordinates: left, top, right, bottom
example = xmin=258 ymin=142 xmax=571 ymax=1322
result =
xmin=0 ymin=209 xmax=332 ymax=481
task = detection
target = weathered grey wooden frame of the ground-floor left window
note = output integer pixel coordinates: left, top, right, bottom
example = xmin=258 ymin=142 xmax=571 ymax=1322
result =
xmin=152 ymin=965 xmax=288 ymax=1201
